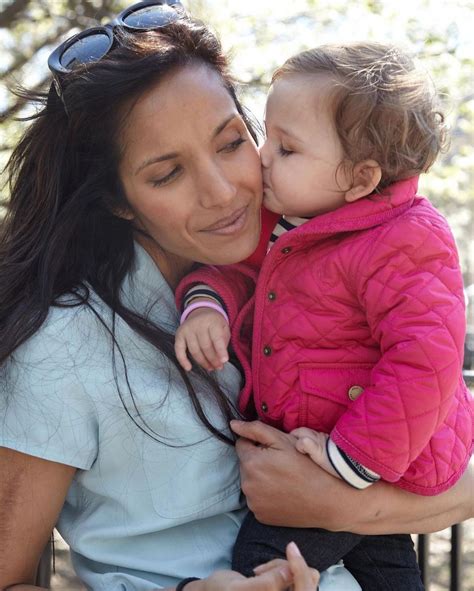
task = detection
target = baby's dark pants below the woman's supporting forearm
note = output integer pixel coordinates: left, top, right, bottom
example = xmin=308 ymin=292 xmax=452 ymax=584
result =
xmin=232 ymin=513 xmax=424 ymax=591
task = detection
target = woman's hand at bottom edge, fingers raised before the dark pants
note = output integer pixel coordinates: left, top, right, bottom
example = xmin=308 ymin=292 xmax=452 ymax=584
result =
xmin=191 ymin=542 xmax=319 ymax=591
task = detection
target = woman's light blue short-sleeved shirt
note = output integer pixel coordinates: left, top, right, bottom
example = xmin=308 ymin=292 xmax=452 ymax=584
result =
xmin=0 ymin=245 xmax=359 ymax=591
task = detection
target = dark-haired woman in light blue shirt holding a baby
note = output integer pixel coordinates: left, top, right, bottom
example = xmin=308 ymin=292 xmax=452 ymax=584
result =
xmin=0 ymin=2 xmax=472 ymax=591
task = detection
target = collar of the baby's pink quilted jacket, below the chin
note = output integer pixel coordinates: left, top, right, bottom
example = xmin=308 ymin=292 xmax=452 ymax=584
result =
xmin=291 ymin=177 xmax=418 ymax=237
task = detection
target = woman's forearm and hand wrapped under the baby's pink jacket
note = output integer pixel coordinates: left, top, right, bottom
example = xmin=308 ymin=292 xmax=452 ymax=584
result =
xmin=232 ymin=421 xmax=474 ymax=535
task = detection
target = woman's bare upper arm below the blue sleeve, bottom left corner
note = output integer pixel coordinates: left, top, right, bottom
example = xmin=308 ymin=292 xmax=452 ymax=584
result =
xmin=0 ymin=447 xmax=76 ymax=591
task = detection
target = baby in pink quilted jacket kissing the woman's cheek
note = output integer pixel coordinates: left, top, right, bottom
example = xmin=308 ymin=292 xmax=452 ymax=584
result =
xmin=176 ymin=43 xmax=473 ymax=591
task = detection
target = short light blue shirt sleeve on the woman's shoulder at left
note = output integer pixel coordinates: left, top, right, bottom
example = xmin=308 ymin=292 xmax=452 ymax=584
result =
xmin=0 ymin=309 xmax=98 ymax=469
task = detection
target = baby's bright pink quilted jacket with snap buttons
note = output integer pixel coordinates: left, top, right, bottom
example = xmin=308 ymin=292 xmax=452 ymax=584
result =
xmin=177 ymin=178 xmax=473 ymax=495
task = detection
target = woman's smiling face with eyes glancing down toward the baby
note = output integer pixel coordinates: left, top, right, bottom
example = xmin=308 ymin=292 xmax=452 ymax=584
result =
xmin=119 ymin=65 xmax=262 ymax=278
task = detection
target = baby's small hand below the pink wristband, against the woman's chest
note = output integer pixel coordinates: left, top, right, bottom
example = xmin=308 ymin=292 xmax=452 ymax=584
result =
xmin=174 ymin=307 xmax=230 ymax=371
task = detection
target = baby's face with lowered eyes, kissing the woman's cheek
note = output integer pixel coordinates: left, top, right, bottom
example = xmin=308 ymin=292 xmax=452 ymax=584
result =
xmin=260 ymin=74 xmax=350 ymax=217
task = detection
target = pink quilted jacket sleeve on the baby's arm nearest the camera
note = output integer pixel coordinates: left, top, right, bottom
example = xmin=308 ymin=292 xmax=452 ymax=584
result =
xmin=331 ymin=215 xmax=465 ymax=482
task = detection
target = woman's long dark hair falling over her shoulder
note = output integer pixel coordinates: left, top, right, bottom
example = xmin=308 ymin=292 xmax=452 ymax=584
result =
xmin=0 ymin=16 xmax=253 ymax=443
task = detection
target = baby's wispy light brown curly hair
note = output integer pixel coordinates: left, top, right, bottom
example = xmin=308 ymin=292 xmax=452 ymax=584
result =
xmin=272 ymin=43 xmax=447 ymax=191
